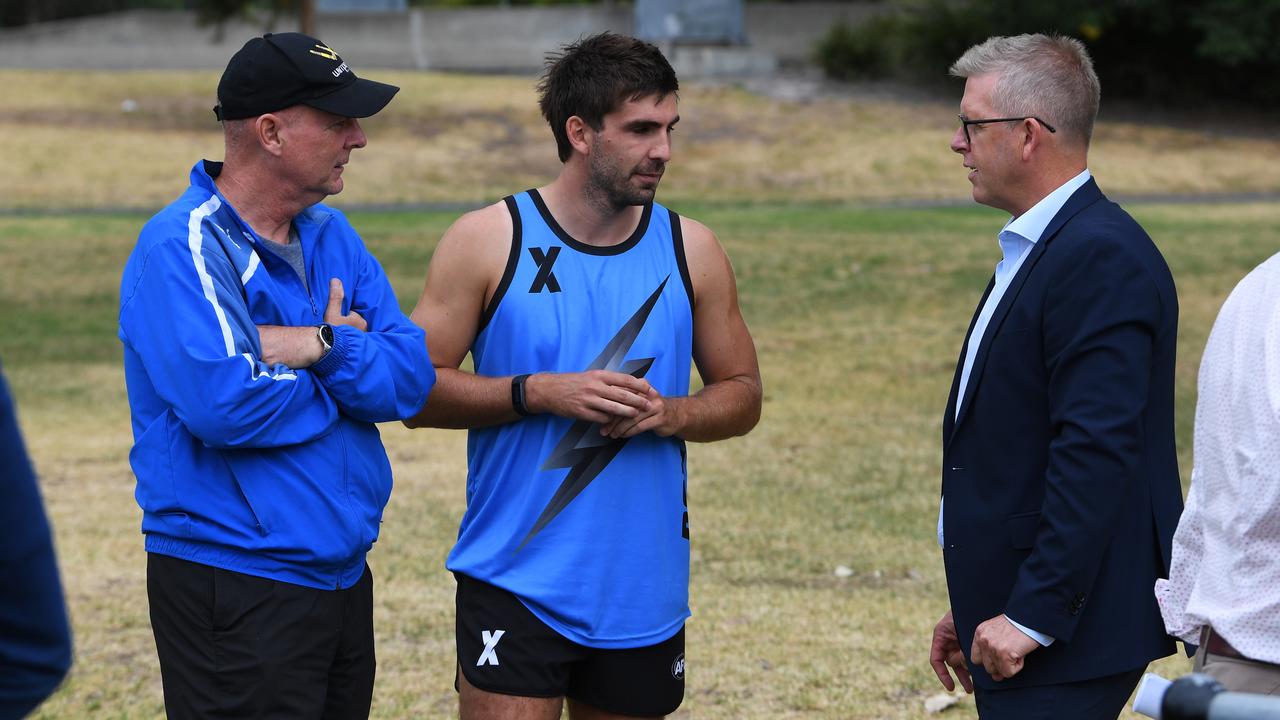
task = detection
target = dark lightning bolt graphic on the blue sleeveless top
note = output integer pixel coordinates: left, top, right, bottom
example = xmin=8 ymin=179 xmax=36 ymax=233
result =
xmin=516 ymin=275 xmax=671 ymax=552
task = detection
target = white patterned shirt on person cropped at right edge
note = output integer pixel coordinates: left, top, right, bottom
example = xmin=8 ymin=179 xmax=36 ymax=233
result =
xmin=1156 ymin=255 xmax=1280 ymax=662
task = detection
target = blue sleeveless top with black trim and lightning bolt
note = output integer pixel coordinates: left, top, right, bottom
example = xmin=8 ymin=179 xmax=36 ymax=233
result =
xmin=447 ymin=190 xmax=692 ymax=648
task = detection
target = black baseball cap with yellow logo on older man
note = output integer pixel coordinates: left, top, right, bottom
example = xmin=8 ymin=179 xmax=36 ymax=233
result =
xmin=214 ymin=32 xmax=399 ymax=120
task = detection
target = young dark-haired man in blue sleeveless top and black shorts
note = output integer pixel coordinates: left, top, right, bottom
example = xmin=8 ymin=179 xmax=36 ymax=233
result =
xmin=407 ymin=33 xmax=762 ymax=720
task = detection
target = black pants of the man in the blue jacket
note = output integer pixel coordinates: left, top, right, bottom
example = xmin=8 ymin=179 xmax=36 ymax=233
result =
xmin=147 ymin=552 xmax=376 ymax=720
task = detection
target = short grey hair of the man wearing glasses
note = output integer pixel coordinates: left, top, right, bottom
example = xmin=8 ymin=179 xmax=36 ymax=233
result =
xmin=951 ymin=35 xmax=1101 ymax=147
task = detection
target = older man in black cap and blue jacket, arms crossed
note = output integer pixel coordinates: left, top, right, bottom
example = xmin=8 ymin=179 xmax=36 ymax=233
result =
xmin=119 ymin=33 xmax=435 ymax=717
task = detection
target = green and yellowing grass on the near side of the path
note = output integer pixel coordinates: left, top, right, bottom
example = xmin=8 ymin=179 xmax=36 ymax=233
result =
xmin=0 ymin=197 xmax=1280 ymax=719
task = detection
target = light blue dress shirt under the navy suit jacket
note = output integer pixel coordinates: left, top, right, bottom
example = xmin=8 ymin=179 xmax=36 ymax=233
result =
xmin=938 ymin=169 xmax=1093 ymax=646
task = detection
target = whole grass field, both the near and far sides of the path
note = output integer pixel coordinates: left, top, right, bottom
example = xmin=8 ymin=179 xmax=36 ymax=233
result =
xmin=0 ymin=64 xmax=1280 ymax=720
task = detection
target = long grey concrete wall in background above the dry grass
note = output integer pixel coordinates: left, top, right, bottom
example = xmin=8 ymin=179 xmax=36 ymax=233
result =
xmin=0 ymin=1 xmax=876 ymax=74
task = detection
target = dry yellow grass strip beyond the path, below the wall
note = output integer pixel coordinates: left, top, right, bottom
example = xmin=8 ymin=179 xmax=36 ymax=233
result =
xmin=0 ymin=70 xmax=1280 ymax=209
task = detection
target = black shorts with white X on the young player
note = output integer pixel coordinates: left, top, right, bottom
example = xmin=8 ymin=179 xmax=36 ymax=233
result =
xmin=454 ymin=574 xmax=685 ymax=717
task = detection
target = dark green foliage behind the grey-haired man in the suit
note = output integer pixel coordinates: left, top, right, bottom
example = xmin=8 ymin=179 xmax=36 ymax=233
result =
xmin=817 ymin=0 xmax=1280 ymax=106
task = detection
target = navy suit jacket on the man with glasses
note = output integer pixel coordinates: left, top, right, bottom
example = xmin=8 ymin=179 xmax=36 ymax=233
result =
xmin=942 ymin=179 xmax=1183 ymax=689
